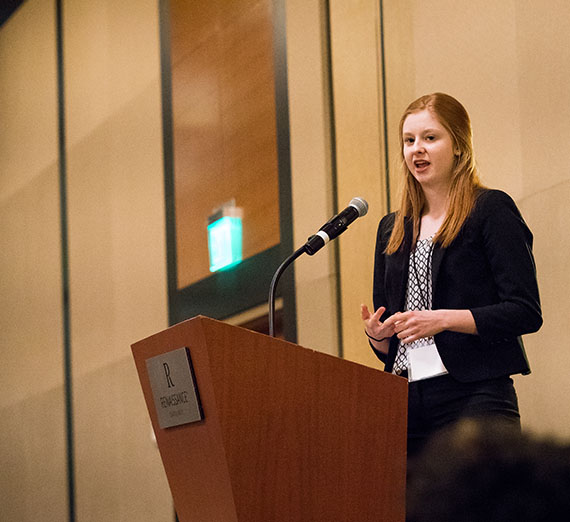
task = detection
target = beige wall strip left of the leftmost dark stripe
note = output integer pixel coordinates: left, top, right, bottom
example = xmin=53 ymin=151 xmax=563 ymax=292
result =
xmin=0 ymin=0 xmax=67 ymax=522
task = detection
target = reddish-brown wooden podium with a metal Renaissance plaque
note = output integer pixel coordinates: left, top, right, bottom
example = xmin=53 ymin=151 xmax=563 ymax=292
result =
xmin=132 ymin=316 xmax=407 ymax=522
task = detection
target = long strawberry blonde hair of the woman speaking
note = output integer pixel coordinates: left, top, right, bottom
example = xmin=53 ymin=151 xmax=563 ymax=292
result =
xmin=386 ymin=92 xmax=482 ymax=254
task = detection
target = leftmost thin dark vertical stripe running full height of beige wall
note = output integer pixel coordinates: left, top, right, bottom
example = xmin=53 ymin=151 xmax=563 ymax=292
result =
xmin=55 ymin=0 xmax=75 ymax=522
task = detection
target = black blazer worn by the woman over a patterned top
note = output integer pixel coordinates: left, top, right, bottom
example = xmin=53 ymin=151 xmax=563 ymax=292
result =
xmin=373 ymin=189 xmax=542 ymax=382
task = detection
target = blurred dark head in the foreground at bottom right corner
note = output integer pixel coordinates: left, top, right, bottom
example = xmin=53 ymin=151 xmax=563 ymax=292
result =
xmin=407 ymin=420 xmax=570 ymax=522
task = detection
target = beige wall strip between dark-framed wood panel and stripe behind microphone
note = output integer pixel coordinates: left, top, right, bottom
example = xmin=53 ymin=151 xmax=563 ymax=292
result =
xmin=286 ymin=0 xmax=340 ymax=355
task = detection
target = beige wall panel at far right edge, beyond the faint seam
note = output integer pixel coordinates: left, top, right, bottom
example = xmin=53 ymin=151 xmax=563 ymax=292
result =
xmin=515 ymin=0 xmax=570 ymax=438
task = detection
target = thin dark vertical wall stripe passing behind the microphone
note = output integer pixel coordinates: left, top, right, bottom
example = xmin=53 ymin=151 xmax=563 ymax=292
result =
xmin=323 ymin=0 xmax=344 ymax=357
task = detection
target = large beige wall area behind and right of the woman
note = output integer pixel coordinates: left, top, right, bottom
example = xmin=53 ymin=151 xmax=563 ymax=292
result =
xmin=388 ymin=0 xmax=570 ymax=436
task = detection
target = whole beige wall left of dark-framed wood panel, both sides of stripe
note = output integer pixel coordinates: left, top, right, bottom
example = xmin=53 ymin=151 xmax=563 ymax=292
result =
xmin=0 ymin=0 xmax=173 ymax=522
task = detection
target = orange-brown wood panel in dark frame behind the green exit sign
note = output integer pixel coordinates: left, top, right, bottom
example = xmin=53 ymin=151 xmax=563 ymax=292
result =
xmin=171 ymin=0 xmax=280 ymax=288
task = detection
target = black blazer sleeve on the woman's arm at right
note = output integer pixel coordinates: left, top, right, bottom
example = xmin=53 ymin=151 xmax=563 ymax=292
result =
xmin=471 ymin=190 xmax=542 ymax=342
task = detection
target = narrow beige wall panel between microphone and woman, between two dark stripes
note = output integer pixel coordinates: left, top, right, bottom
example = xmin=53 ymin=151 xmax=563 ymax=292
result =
xmin=330 ymin=0 xmax=386 ymax=365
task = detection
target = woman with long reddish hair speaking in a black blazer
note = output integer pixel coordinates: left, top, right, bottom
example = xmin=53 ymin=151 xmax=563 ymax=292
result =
xmin=361 ymin=93 xmax=542 ymax=456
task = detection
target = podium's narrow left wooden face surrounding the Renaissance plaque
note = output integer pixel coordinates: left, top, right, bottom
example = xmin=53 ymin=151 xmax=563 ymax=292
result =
xmin=132 ymin=314 xmax=238 ymax=522
